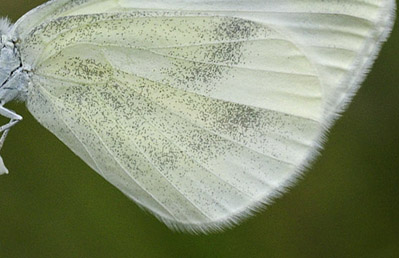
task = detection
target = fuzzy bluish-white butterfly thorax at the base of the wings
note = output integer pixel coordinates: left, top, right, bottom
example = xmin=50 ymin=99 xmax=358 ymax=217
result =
xmin=0 ymin=29 xmax=29 ymax=105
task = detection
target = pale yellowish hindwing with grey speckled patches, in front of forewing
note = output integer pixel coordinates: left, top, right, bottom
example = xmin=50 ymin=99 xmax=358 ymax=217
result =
xmin=23 ymin=13 xmax=322 ymax=230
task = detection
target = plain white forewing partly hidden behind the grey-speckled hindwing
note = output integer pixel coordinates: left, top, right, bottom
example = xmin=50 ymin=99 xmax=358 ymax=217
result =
xmin=14 ymin=0 xmax=396 ymax=121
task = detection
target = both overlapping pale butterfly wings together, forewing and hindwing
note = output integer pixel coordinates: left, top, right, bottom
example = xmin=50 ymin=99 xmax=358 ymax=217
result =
xmin=0 ymin=0 xmax=396 ymax=233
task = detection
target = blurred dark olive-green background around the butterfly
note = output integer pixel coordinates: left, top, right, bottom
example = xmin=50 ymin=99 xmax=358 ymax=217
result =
xmin=0 ymin=0 xmax=399 ymax=258
